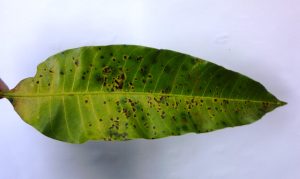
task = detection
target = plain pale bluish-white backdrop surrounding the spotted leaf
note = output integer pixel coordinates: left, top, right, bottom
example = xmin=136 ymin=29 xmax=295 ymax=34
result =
xmin=0 ymin=0 xmax=300 ymax=179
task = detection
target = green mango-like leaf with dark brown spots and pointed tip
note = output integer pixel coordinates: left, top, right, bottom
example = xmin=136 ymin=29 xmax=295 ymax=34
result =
xmin=0 ymin=45 xmax=285 ymax=143
